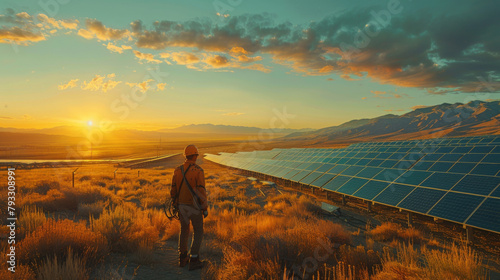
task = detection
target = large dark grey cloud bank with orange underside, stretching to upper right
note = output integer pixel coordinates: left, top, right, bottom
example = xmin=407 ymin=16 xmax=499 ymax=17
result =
xmin=128 ymin=5 xmax=500 ymax=92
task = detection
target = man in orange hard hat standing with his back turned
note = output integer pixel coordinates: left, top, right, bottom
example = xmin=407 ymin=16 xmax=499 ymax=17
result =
xmin=170 ymin=145 xmax=208 ymax=270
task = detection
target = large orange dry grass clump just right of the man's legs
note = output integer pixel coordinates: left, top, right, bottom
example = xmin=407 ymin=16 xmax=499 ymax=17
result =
xmin=201 ymin=196 xmax=350 ymax=279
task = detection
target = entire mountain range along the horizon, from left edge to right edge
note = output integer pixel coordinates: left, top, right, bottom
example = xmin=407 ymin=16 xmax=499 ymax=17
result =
xmin=0 ymin=101 xmax=500 ymax=146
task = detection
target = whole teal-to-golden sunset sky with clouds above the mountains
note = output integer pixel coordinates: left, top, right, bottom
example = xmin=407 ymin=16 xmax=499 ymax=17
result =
xmin=0 ymin=0 xmax=500 ymax=130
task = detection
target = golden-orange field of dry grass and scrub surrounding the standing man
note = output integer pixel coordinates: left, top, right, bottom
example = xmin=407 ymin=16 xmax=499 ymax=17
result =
xmin=0 ymin=162 xmax=488 ymax=279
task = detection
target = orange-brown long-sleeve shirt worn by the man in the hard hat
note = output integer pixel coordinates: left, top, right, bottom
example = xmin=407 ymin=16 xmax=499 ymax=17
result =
xmin=170 ymin=160 xmax=208 ymax=210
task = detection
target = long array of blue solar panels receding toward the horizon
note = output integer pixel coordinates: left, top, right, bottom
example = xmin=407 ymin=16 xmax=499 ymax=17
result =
xmin=205 ymin=135 xmax=500 ymax=233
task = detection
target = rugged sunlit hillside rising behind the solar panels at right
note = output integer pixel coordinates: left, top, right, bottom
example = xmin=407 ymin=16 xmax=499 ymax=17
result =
xmin=283 ymin=101 xmax=500 ymax=144
